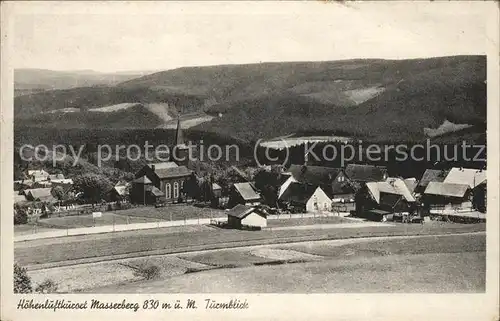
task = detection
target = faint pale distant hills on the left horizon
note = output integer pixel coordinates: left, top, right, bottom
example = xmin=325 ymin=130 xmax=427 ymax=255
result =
xmin=14 ymin=69 xmax=154 ymax=96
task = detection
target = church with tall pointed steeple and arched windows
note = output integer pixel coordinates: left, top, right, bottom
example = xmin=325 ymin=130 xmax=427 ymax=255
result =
xmin=130 ymin=118 xmax=192 ymax=205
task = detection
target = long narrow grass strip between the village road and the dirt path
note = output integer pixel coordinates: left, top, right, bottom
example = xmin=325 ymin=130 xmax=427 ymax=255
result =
xmin=14 ymin=222 xmax=485 ymax=265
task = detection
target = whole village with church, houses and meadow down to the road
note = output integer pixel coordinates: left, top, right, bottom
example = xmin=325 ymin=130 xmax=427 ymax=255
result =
xmin=14 ymin=120 xmax=487 ymax=234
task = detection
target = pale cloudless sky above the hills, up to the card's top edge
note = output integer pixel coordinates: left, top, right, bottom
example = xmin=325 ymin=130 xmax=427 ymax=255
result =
xmin=10 ymin=1 xmax=491 ymax=72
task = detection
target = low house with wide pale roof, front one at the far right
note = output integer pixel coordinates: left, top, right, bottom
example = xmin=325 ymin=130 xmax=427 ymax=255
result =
xmin=422 ymin=182 xmax=472 ymax=214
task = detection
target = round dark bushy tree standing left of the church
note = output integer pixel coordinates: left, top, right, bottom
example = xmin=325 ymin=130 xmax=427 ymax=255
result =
xmin=74 ymin=174 xmax=113 ymax=203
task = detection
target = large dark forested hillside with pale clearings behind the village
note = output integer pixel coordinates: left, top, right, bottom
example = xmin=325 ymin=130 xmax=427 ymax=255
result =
xmin=15 ymin=56 xmax=486 ymax=141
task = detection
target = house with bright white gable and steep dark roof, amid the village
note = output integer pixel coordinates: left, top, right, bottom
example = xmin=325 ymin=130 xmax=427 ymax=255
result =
xmin=279 ymin=182 xmax=332 ymax=213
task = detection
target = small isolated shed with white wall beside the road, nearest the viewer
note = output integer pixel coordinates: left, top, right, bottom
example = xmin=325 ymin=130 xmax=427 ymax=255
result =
xmin=227 ymin=204 xmax=267 ymax=229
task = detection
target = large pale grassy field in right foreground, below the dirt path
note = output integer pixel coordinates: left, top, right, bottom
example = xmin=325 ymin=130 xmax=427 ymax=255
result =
xmin=88 ymin=235 xmax=486 ymax=293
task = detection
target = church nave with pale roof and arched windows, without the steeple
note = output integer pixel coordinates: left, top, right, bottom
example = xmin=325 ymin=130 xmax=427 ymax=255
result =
xmin=132 ymin=162 xmax=192 ymax=202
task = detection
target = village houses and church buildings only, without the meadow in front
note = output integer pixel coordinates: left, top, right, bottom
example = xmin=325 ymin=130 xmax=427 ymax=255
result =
xmin=14 ymin=120 xmax=486 ymax=227
